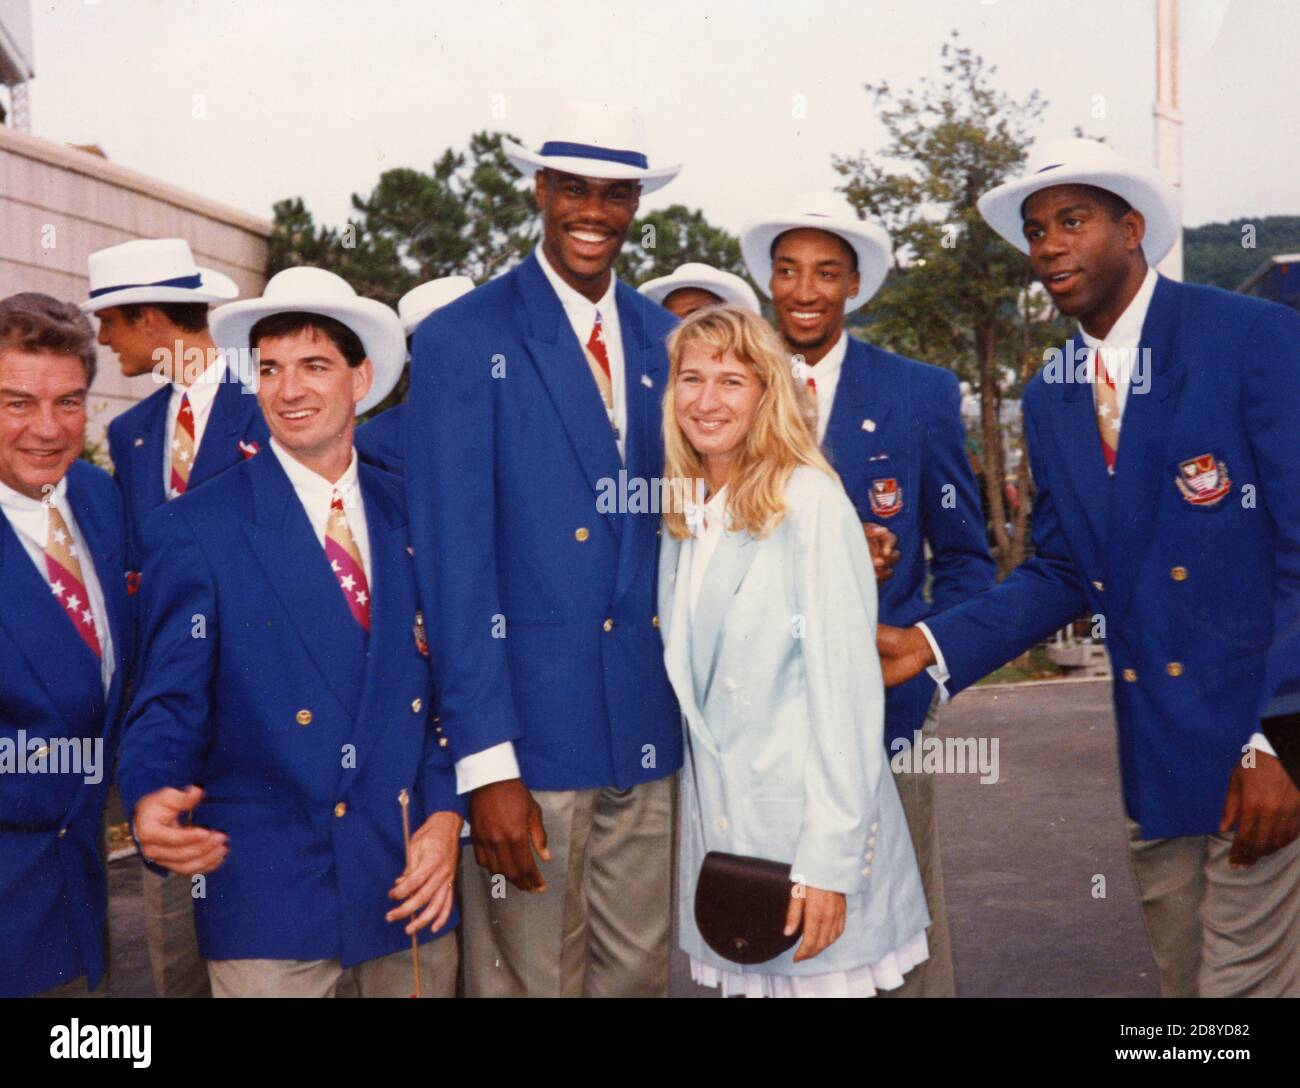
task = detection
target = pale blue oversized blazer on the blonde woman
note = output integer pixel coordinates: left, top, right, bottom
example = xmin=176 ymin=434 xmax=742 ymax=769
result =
xmin=659 ymin=468 xmax=930 ymax=975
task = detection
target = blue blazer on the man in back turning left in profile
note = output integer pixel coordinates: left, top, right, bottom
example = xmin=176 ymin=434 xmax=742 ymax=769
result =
xmin=108 ymin=372 xmax=270 ymax=569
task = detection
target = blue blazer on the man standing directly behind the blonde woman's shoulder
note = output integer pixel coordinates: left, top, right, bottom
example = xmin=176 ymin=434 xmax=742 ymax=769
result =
xmin=823 ymin=337 xmax=997 ymax=745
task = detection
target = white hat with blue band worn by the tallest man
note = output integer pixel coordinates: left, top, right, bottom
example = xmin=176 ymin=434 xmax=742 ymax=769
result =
xmin=501 ymin=101 xmax=681 ymax=194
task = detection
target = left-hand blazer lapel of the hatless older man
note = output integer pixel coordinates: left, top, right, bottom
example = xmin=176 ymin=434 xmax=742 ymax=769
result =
xmin=0 ymin=501 xmax=102 ymax=732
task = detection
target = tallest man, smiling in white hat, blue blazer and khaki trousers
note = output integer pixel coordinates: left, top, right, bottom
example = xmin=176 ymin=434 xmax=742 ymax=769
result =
xmin=406 ymin=103 xmax=681 ymax=996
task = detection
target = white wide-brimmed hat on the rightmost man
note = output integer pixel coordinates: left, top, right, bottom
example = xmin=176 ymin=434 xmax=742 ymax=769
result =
xmin=979 ymin=138 xmax=1182 ymax=264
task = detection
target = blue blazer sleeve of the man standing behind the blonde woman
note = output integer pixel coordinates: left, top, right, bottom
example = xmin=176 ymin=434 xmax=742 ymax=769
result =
xmin=920 ymin=372 xmax=997 ymax=612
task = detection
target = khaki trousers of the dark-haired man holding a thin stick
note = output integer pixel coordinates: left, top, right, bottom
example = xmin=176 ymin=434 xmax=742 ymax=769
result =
xmin=208 ymin=933 xmax=456 ymax=997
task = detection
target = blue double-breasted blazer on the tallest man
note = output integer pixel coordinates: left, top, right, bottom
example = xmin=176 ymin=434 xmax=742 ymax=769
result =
xmin=404 ymin=256 xmax=681 ymax=789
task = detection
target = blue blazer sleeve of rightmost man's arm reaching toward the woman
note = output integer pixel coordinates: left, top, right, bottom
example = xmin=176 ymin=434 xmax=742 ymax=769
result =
xmin=926 ymin=395 xmax=1088 ymax=694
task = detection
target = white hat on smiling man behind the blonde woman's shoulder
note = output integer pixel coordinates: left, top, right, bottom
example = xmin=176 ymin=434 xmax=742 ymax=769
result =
xmin=740 ymin=192 xmax=893 ymax=313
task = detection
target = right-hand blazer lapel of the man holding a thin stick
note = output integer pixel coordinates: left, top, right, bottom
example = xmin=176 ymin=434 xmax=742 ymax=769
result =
xmin=345 ymin=470 xmax=416 ymax=774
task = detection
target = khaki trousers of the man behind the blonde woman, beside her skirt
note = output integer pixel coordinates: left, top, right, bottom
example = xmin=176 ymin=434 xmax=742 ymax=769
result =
xmin=876 ymin=697 xmax=957 ymax=997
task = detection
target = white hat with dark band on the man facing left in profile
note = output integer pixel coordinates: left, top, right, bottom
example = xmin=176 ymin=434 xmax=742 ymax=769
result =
xmin=81 ymin=238 xmax=239 ymax=313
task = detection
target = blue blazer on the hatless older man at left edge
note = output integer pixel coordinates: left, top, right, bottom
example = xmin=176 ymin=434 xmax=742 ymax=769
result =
xmin=0 ymin=461 xmax=134 ymax=997
